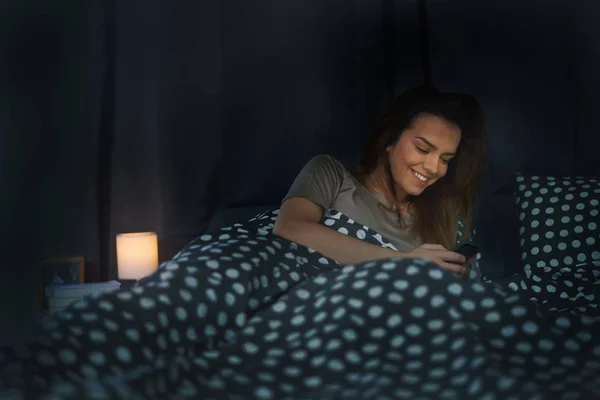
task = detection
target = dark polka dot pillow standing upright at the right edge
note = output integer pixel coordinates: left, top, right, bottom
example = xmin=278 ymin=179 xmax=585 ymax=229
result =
xmin=515 ymin=174 xmax=600 ymax=272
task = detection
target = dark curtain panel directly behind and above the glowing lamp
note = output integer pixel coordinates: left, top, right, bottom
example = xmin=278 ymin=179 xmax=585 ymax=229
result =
xmin=100 ymin=0 xmax=221 ymax=279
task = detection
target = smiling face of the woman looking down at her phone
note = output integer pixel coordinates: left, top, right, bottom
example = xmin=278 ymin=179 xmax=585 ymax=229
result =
xmin=387 ymin=114 xmax=461 ymax=201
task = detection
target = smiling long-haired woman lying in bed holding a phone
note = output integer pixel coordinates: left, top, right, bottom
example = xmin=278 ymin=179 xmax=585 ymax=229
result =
xmin=273 ymin=86 xmax=487 ymax=272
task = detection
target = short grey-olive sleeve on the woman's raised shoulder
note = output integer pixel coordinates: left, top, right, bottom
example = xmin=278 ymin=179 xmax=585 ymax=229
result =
xmin=281 ymin=155 xmax=345 ymax=210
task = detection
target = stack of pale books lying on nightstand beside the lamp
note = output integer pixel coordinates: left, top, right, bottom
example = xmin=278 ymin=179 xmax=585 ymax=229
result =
xmin=45 ymin=281 xmax=121 ymax=314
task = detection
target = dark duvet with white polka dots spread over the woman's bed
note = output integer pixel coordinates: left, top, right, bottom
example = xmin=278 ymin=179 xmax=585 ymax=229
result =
xmin=0 ymin=211 xmax=600 ymax=400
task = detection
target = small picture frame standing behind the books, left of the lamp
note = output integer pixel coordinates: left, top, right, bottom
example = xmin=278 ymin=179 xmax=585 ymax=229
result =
xmin=38 ymin=256 xmax=85 ymax=312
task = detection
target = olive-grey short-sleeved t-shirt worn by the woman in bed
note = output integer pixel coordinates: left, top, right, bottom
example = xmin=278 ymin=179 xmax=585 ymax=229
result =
xmin=282 ymin=155 xmax=421 ymax=252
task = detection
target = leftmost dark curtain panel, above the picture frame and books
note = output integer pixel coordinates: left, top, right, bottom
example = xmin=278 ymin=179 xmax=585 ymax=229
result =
xmin=0 ymin=0 xmax=107 ymax=342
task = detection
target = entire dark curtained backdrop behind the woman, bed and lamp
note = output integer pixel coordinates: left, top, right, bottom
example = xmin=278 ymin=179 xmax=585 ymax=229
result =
xmin=0 ymin=0 xmax=600 ymax=341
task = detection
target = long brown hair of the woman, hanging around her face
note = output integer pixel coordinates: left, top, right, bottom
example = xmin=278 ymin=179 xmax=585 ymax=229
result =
xmin=355 ymin=86 xmax=488 ymax=248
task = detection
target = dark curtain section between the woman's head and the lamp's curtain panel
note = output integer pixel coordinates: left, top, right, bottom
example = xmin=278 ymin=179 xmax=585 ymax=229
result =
xmin=221 ymin=0 xmax=398 ymax=209
